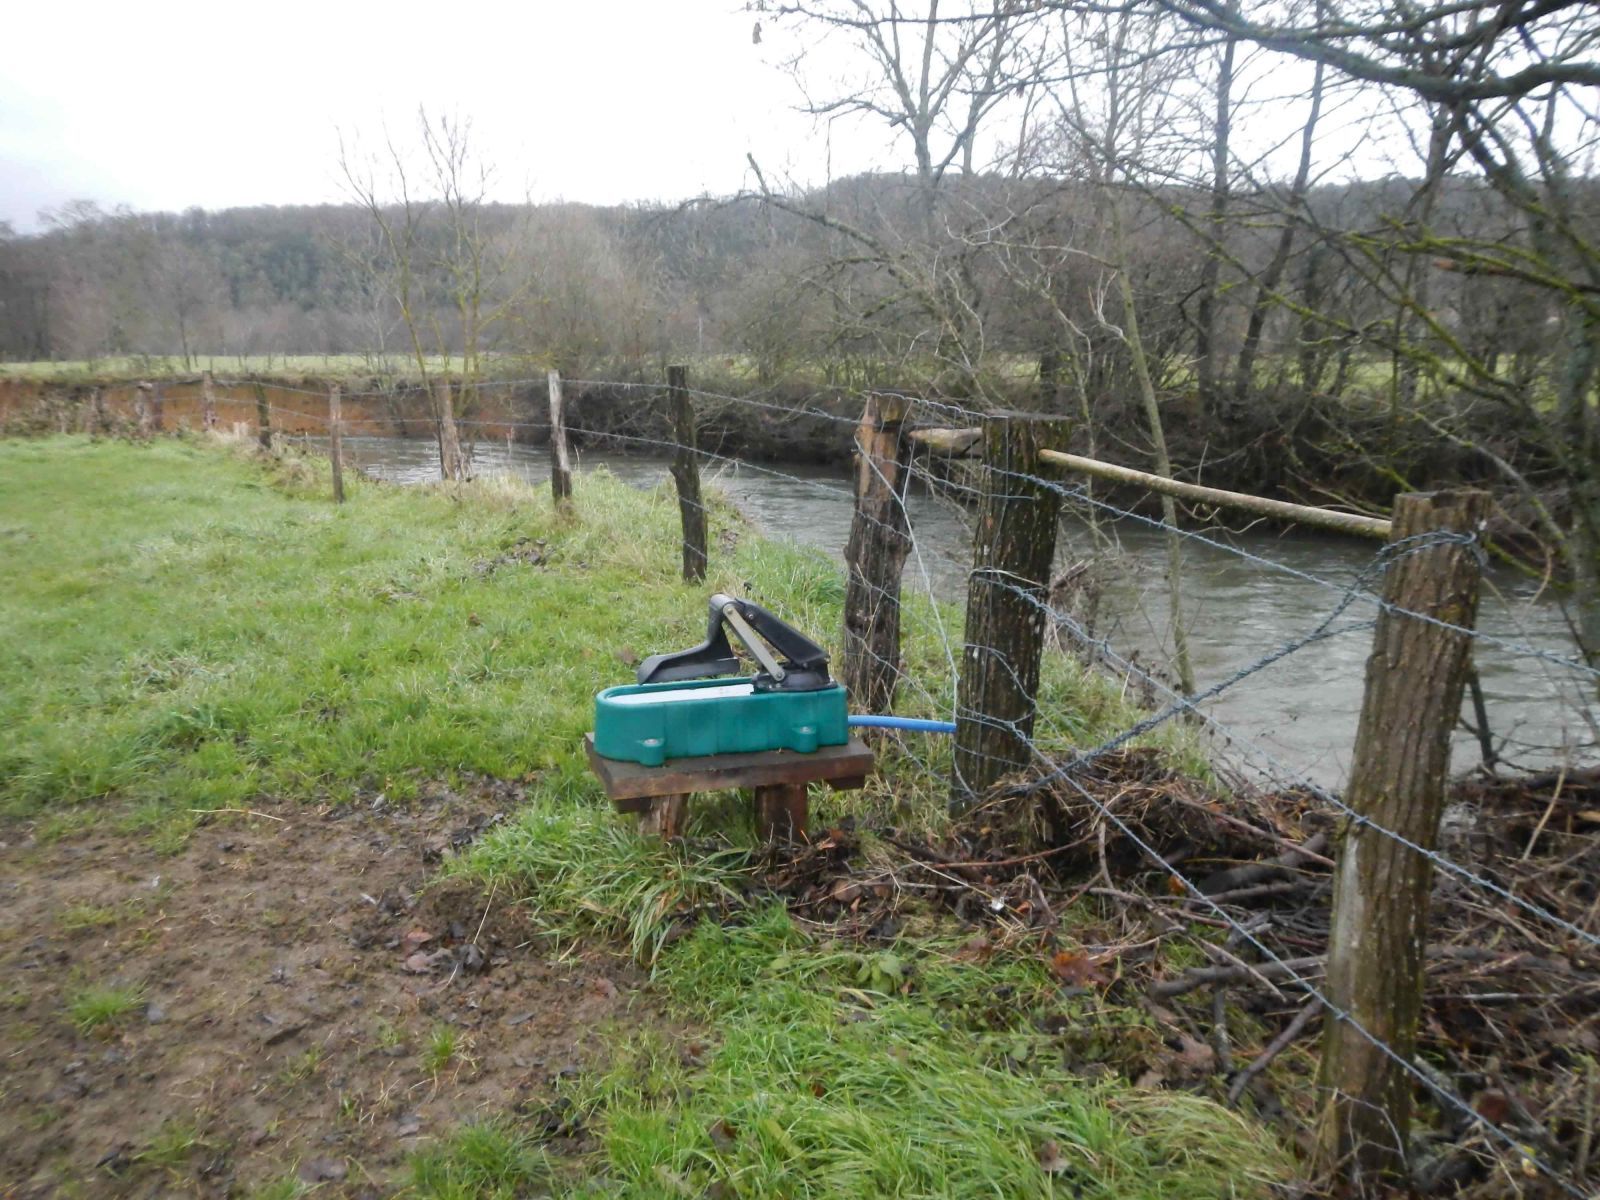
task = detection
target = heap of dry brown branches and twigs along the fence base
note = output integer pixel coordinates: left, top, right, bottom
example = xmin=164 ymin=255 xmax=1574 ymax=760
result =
xmin=766 ymin=750 xmax=1600 ymax=1197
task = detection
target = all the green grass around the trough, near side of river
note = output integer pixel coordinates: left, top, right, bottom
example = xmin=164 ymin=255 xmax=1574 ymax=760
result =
xmin=0 ymin=438 xmax=1290 ymax=1200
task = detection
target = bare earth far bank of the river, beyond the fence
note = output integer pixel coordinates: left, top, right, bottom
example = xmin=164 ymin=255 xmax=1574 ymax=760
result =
xmin=0 ymin=376 xmax=1565 ymax=562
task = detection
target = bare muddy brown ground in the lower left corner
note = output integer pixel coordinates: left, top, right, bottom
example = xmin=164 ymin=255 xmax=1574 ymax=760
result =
xmin=0 ymin=787 xmax=658 ymax=1200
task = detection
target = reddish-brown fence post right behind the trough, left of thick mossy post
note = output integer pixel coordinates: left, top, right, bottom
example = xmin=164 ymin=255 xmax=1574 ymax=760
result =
xmin=842 ymin=395 xmax=912 ymax=712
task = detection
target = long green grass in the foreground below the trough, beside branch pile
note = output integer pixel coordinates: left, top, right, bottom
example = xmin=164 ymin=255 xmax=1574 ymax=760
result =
xmin=531 ymin=909 xmax=1288 ymax=1200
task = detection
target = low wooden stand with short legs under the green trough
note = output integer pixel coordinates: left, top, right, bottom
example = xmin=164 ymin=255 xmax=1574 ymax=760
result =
xmin=584 ymin=733 xmax=872 ymax=840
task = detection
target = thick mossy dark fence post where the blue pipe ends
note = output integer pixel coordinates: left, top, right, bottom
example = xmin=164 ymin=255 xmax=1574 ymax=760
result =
xmin=950 ymin=413 xmax=1072 ymax=808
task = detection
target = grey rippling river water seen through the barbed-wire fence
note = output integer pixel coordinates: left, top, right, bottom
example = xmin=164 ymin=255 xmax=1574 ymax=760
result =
xmin=324 ymin=437 xmax=1600 ymax=787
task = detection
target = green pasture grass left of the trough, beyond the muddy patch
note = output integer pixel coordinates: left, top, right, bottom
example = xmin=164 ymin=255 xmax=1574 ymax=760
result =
xmin=0 ymin=438 xmax=812 ymax=829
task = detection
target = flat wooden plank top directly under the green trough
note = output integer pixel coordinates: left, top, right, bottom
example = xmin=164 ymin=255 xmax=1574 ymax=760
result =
xmin=584 ymin=733 xmax=874 ymax=811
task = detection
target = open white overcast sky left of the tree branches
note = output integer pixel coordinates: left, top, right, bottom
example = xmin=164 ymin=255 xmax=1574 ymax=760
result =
xmin=0 ymin=0 xmax=883 ymax=230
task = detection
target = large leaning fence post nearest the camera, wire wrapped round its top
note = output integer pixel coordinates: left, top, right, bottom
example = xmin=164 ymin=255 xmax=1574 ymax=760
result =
xmin=1317 ymin=491 xmax=1490 ymax=1174
